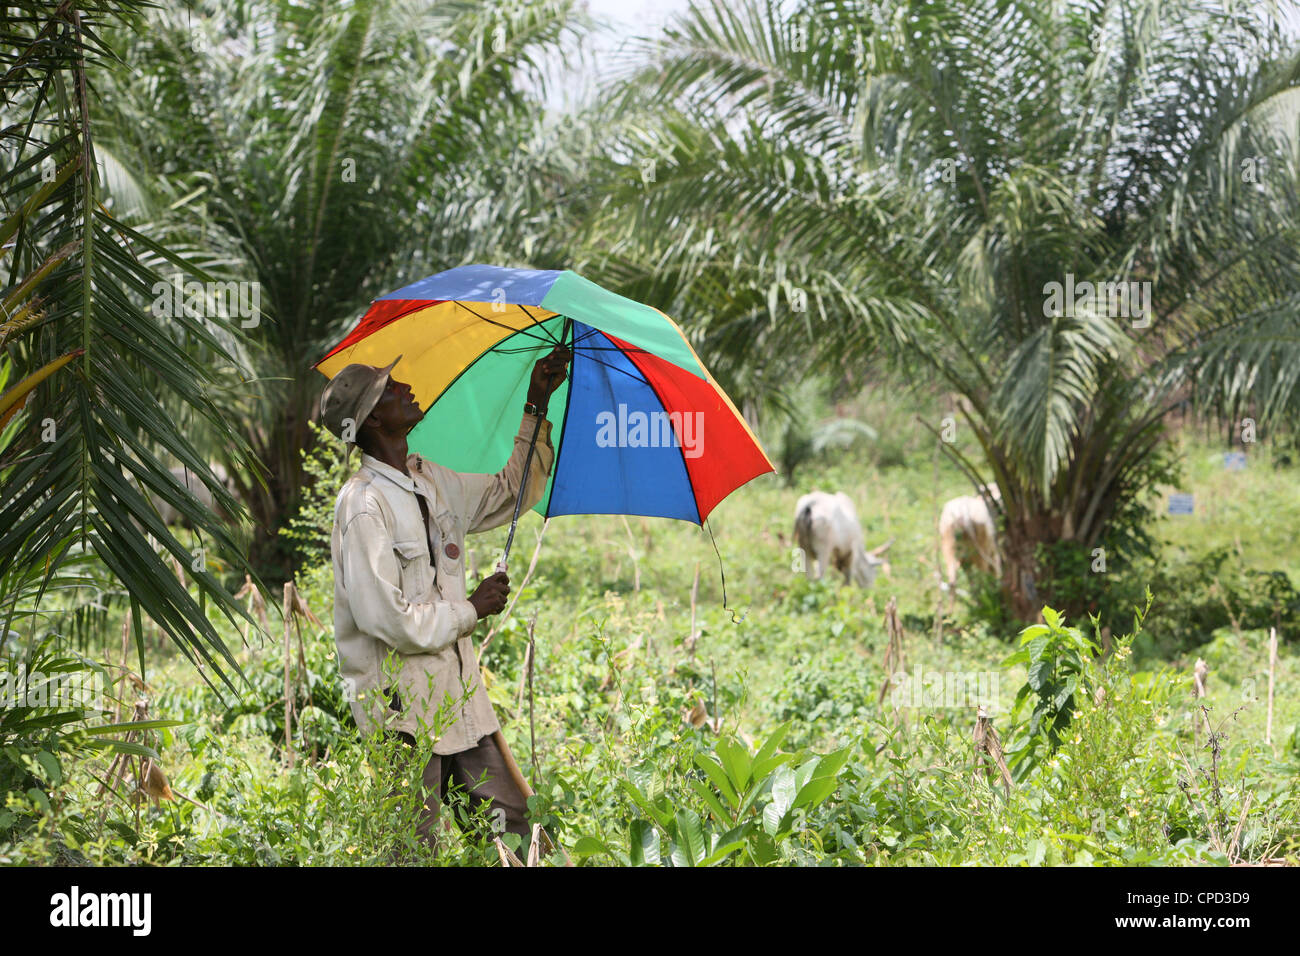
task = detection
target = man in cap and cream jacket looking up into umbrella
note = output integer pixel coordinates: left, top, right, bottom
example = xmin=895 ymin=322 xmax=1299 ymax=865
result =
xmin=321 ymin=347 xmax=571 ymax=847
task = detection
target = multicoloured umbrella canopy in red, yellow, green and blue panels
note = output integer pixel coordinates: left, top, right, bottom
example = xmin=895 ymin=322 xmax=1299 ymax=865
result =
xmin=316 ymin=265 xmax=776 ymax=524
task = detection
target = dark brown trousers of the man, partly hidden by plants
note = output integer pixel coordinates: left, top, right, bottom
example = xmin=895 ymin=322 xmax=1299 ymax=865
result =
xmin=387 ymin=731 xmax=529 ymax=852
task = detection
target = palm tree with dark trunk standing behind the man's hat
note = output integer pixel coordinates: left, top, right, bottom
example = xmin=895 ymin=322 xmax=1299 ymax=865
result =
xmin=94 ymin=0 xmax=582 ymax=575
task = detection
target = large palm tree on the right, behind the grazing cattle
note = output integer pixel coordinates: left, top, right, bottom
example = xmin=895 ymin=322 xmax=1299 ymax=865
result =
xmin=592 ymin=0 xmax=1300 ymax=618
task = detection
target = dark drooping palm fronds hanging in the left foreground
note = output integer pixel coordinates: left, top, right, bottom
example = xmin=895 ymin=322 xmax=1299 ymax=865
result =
xmin=0 ymin=3 xmax=263 ymax=687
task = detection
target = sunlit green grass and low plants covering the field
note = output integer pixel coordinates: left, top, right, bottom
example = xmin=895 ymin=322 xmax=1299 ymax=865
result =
xmin=0 ymin=394 xmax=1300 ymax=865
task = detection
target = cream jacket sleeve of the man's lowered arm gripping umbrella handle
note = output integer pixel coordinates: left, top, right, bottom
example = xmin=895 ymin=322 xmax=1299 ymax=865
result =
xmin=342 ymin=511 xmax=478 ymax=654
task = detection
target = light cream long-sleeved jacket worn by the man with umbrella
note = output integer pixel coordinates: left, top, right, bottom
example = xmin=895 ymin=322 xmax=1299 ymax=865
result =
xmin=330 ymin=414 xmax=555 ymax=754
